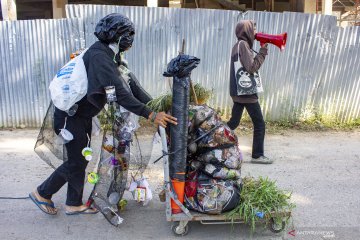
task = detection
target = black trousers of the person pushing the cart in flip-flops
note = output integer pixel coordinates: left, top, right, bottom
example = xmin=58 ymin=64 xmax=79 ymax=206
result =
xmin=37 ymin=116 xmax=92 ymax=206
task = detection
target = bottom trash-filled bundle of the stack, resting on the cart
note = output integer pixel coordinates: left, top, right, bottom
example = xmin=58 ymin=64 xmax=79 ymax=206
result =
xmin=185 ymin=172 xmax=241 ymax=214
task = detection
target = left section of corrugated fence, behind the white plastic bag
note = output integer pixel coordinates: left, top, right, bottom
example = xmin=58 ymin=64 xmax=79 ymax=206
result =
xmin=0 ymin=19 xmax=85 ymax=127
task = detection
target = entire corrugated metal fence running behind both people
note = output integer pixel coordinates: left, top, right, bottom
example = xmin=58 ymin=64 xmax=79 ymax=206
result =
xmin=0 ymin=5 xmax=360 ymax=127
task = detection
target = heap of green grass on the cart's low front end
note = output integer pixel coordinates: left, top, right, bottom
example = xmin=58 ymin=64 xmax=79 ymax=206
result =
xmin=228 ymin=177 xmax=295 ymax=231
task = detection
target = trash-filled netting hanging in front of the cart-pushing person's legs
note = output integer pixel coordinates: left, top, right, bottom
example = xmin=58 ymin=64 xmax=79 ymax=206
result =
xmin=88 ymin=104 xmax=156 ymax=226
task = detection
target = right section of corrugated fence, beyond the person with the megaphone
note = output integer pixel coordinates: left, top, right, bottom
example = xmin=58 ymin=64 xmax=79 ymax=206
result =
xmin=245 ymin=12 xmax=360 ymax=122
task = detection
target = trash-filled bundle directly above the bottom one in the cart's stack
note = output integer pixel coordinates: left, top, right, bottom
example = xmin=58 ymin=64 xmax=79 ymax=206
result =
xmin=197 ymin=146 xmax=242 ymax=169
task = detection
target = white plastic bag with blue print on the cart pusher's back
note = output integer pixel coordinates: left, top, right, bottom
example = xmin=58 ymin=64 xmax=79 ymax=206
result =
xmin=49 ymin=50 xmax=88 ymax=111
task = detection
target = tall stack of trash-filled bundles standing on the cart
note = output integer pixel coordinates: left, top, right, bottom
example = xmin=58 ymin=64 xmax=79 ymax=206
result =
xmin=185 ymin=105 xmax=242 ymax=214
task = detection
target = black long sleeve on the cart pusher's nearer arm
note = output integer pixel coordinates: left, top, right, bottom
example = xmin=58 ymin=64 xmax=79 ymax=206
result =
xmin=90 ymin=54 xmax=151 ymax=118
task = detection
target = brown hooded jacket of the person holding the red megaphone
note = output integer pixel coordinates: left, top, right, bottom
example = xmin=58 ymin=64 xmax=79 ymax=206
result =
xmin=230 ymin=20 xmax=267 ymax=103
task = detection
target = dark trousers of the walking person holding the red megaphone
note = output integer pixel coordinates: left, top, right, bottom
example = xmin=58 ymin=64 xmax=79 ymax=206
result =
xmin=227 ymin=102 xmax=265 ymax=158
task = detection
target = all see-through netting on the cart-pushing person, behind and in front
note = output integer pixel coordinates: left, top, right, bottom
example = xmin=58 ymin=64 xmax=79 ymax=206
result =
xmin=34 ymin=103 xmax=157 ymax=226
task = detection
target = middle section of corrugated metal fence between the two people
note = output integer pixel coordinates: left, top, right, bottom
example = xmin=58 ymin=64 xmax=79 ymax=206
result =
xmin=67 ymin=5 xmax=239 ymax=116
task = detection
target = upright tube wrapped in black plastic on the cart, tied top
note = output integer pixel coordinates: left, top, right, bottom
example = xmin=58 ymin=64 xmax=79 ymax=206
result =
xmin=164 ymin=55 xmax=200 ymax=182
